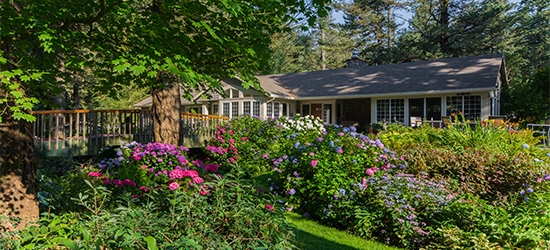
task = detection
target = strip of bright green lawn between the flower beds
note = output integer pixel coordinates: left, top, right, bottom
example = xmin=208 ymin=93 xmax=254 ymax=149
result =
xmin=286 ymin=213 xmax=404 ymax=250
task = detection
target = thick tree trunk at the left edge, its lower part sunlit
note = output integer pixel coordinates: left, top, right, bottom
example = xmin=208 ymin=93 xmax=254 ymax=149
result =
xmin=0 ymin=117 xmax=39 ymax=232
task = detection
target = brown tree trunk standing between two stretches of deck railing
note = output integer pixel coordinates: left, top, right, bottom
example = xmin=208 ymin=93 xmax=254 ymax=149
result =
xmin=152 ymin=74 xmax=182 ymax=145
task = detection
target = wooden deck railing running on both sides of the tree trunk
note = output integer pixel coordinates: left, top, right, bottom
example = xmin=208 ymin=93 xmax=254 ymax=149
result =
xmin=32 ymin=109 xmax=229 ymax=155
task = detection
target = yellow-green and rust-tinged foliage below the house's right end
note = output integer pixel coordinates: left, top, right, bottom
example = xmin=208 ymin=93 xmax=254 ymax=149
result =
xmin=381 ymin=124 xmax=549 ymax=203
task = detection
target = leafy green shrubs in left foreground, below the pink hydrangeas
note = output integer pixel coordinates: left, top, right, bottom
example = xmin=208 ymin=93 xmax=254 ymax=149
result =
xmin=4 ymin=178 xmax=293 ymax=249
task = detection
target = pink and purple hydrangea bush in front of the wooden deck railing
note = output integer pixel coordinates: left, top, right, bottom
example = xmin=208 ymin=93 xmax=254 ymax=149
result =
xmin=88 ymin=142 xmax=218 ymax=197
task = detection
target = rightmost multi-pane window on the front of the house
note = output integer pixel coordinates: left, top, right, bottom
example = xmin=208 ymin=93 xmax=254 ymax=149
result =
xmin=446 ymin=95 xmax=481 ymax=120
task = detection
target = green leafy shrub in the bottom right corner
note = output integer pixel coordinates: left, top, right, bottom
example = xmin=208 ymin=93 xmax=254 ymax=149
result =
xmin=426 ymin=192 xmax=550 ymax=249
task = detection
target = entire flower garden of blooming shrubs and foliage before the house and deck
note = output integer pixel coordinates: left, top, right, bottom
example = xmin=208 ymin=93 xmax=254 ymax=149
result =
xmin=0 ymin=116 xmax=550 ymax=249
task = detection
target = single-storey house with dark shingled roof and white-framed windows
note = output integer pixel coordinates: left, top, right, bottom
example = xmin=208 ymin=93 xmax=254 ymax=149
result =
xmin=135 ymin=54 xmax=507 ymax=130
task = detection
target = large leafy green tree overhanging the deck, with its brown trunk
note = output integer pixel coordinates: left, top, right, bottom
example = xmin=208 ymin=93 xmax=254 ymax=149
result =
xmin=0 ymin=0 xmax=328 ymax=229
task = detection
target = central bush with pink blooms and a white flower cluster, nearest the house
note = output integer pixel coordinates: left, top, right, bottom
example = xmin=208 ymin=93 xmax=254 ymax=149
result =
xmin=205 ymin=115 xmax=325 ymax=177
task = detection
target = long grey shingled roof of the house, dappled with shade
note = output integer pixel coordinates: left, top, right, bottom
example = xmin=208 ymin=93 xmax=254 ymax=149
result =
xmin=258 ymin=54 xmax=506 ymax=99
